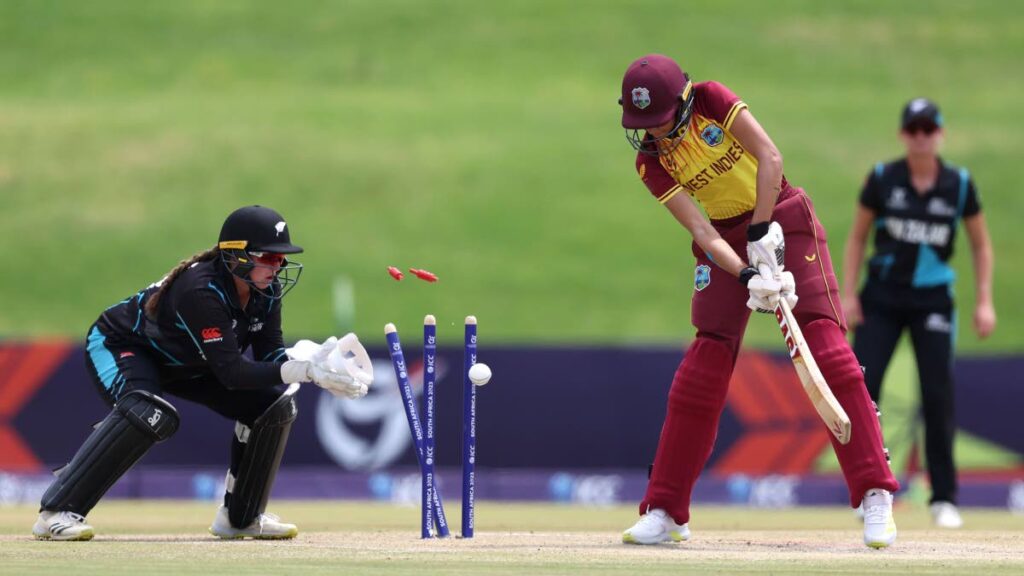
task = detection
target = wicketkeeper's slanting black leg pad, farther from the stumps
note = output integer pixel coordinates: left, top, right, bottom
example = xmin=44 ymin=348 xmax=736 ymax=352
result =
xmin=41 ymin=390 xmax=178 ymax=516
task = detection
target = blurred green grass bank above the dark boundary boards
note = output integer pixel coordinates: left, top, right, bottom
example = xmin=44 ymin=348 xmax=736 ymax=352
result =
xmin=0 ymin=0 xmax=1024 ymax=351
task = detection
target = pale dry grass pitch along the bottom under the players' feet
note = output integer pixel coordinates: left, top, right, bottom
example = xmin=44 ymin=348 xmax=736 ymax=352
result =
xmin=0 ymin=501 xmax=1024 ymax=576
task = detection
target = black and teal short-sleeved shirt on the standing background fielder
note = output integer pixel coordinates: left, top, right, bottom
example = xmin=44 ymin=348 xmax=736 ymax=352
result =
xmin=860 ymin=158 xmax=981 ymax=288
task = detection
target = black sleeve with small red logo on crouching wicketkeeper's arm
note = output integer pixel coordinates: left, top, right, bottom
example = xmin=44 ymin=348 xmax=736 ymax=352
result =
xmin=175 ymin=289 xmax=282 ymax=389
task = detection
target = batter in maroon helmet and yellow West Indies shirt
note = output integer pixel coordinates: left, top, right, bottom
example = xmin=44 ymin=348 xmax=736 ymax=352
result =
xmin=621 ymin=54 xmax=899 ymax=547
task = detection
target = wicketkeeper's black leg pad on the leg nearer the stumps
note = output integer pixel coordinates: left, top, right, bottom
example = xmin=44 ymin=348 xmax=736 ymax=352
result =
xmin=227 ymin=384 xmax=299 ymax=528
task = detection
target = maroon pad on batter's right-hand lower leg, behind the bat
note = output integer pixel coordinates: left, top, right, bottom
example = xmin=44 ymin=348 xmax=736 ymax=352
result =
xmin=803 ymin=319 xmax=899 ymax=506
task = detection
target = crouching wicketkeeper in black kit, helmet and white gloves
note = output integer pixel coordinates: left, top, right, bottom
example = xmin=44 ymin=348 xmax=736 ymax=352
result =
xmin=32 ymin=206 xmax=372 ymax=540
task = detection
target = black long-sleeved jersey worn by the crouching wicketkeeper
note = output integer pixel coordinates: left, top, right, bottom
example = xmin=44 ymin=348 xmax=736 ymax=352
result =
xmin=89 ymin=258 xmax=287 ymax=388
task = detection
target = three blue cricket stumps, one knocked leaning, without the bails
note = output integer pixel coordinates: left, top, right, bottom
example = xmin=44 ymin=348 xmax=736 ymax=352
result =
xmin=384 ymin=315 xmax=476 ymax=538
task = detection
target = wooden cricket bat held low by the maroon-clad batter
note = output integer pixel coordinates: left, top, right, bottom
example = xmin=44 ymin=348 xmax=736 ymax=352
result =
xmin=775 ymin=298 xmax=850 ymax=444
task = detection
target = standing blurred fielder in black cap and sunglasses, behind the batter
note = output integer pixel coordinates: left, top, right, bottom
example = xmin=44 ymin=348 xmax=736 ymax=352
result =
xmin=843 ymin=98 xmax=995 ymax=528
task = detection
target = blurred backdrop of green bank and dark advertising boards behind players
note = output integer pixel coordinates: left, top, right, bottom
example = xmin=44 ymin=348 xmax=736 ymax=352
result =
xmin=0 ymin=0 xmax=1024 ymax=509
